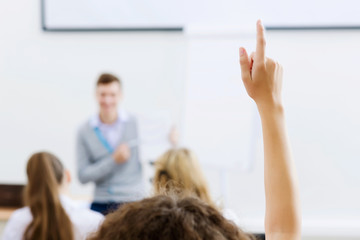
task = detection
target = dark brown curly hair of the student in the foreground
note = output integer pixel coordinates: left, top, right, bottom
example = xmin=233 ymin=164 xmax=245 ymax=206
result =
xmin=88 ymin=195 xmax=255 ymax=240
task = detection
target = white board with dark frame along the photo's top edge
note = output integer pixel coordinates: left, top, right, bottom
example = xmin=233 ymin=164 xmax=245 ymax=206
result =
xmin=42 ymin=0 xmax=360 ymax=30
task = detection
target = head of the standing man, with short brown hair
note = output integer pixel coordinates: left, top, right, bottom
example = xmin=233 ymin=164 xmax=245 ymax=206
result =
xmin=96 ymin=73 xmax=123 ymax=115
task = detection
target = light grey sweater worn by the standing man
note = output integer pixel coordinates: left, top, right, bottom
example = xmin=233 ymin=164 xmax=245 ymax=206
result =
xmin=76 ymin=117 xmax=144 ymax=203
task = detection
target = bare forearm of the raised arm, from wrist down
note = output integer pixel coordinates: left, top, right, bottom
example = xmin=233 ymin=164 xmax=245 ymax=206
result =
xmin=258 ymin=104 xmax=300 ymax=233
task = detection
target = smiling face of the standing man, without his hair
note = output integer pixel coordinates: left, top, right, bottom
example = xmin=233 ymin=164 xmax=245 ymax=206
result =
xmin=96 ymin=82 xmax=122 ymax=113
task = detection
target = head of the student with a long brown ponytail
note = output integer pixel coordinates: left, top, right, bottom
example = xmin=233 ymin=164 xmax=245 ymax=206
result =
xmin=24 ymin=152 xmax=73 ymax=240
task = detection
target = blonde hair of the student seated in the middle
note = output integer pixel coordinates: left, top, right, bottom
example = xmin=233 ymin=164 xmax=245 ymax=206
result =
xmin=153 ymin=148 xmax=215 ymax=207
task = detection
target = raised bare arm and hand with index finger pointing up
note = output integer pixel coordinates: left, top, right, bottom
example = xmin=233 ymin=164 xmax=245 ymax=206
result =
xmin=240 ymin=21 xmax=301 ymax=240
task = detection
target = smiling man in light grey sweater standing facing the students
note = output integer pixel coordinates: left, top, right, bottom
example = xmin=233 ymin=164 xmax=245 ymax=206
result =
xmin=76 ymin=73 xmax=144 ymax=215
